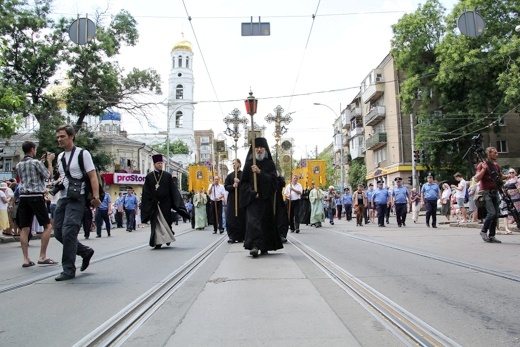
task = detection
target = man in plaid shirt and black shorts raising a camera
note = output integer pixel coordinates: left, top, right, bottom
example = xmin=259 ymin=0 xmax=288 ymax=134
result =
xmin=15 ymin=141 xmax=57 ymax=267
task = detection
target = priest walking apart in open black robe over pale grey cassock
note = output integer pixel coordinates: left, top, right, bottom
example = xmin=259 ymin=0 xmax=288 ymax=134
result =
xmin=141 ymin=154 xmax=190 ymax=249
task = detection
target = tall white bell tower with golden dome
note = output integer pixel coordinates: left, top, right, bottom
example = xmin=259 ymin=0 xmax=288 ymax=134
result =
xmin=167 ymin=34 xmax=195 ymax=167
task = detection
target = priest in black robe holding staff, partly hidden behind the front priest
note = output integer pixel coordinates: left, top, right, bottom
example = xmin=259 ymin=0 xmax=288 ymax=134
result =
xmin=224 ymin=158 xmax=246 ymax=243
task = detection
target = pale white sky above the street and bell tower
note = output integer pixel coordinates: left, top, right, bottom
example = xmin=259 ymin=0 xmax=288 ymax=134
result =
xmin=50 ymin=0 xmax=457 ymax=156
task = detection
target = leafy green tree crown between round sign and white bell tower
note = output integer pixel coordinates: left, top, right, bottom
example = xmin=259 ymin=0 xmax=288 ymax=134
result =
xmin=65 ymin=10 xmax=161 ymax=129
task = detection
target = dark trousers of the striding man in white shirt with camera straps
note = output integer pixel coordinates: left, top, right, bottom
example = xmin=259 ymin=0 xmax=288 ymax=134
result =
xmin=54 ymin=195 xmax=91 ymax=276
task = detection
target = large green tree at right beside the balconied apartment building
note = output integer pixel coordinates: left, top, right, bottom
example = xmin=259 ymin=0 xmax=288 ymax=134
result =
xmin=392 ymin=0 xmax=520 ymax=171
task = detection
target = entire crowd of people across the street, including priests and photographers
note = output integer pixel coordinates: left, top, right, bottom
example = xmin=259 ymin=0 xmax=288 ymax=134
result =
xmin=5 ymin=133 xmax=520 ymax=274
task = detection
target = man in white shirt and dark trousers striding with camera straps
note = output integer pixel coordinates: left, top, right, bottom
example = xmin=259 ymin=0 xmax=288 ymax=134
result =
xmin=54 ymin=125 xmax=101 ymax=281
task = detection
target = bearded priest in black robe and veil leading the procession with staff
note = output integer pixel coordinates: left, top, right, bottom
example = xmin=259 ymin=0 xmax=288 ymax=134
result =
xmin=239 ymin=137 xmax=283 ymax=258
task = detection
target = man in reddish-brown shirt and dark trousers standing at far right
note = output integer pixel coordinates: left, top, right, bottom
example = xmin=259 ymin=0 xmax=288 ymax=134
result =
xmin=475 ymin=147 xmax=507 ymax=243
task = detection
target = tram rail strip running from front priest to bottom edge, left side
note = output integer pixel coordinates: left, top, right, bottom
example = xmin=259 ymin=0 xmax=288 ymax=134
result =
xmin=74 ymin=236 xmax=227 ymax=347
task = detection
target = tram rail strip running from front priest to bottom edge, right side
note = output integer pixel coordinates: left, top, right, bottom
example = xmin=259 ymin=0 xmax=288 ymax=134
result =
xmin=289 ymin=236 xmax=460 ymax=347
